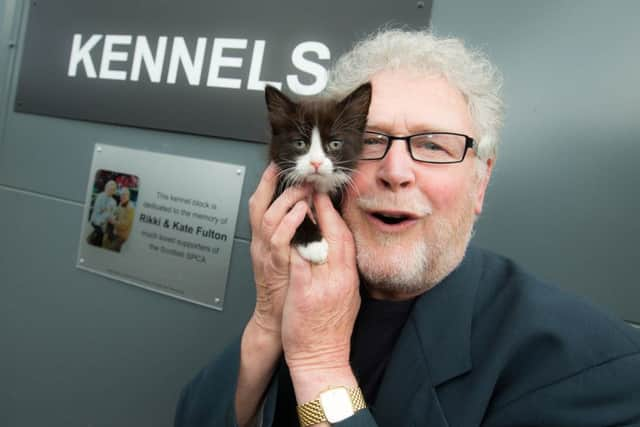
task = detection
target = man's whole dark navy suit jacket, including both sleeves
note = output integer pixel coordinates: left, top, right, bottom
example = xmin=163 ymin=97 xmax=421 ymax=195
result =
xmin=175 ymin=248 xmax=640 ymax=427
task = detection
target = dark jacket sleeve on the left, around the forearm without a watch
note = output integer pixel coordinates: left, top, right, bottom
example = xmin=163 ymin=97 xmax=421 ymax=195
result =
xmin=174 ymin=338 xmax=277 ymax=427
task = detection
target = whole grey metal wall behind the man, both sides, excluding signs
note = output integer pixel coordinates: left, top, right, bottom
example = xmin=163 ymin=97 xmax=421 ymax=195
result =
xmin=0 ymin=0 xmax=640 ymax=427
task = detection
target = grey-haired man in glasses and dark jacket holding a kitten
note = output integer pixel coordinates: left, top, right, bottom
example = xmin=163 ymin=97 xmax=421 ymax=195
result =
xmin=176 ymin=30 xmax=640 ymax=427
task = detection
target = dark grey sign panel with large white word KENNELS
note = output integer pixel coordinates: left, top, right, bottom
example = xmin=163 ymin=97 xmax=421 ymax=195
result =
xmin=15 ymin=0 xmax=431 ymax=142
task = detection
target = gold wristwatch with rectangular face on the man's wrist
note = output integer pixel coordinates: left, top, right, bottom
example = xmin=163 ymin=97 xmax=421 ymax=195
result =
xmin=296 ymin=387 xmax=367 ymax=427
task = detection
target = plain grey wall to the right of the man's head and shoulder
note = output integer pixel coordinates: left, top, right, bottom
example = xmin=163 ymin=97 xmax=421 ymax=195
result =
xmin=432 ymin=0 xmax=640 ymax=323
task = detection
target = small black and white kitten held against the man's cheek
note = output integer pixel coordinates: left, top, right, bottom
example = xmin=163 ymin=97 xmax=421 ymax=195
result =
xmin=265 ymin=83 xmax=371 ymax=264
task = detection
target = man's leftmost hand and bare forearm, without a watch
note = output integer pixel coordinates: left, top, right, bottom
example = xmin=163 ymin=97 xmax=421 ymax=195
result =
xmin=235 ymin=164 xmax=309 ymax=426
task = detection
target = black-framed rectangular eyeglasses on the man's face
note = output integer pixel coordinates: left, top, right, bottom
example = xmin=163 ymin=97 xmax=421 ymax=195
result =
xmin=360 ymin=131 xmax=475 ymax=163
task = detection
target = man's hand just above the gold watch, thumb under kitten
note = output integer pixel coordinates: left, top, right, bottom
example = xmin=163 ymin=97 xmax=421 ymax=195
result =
xmin=282 ymin=194 xmax=360 ymax=403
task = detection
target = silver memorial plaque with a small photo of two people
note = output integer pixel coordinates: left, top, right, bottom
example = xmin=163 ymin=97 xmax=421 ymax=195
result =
xmin=77 ymin=144 xmax=245 ymax=310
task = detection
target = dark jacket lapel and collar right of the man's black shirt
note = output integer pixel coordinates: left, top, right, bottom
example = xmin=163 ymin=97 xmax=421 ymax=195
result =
xmin=371 ymin=248 xmax=481 ymax=427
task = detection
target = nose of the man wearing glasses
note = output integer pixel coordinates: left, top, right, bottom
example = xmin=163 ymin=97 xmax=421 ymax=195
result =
xmin=377 ymin=140 xmax=415 ymax=191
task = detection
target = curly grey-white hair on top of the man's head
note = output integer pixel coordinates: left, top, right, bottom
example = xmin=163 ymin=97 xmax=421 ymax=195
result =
xmin=325 ymin=29 xmax=503 ymax=164
